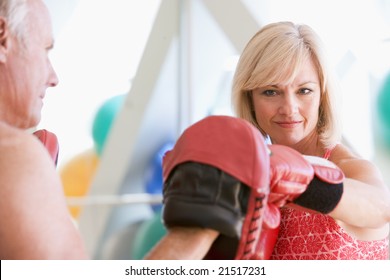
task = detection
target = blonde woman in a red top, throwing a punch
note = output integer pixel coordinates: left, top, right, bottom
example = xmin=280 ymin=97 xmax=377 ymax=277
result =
xmin=233 ymin=22 xmax=390 ymax=259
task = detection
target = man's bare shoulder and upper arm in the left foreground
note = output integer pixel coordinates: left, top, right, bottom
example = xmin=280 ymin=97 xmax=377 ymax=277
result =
xmin=0 ymin=123 xmax=87 ymax=259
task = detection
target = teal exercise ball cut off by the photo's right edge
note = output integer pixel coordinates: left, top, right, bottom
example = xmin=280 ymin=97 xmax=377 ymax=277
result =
xmin=378 ymin=73 xmax=390 ymax=146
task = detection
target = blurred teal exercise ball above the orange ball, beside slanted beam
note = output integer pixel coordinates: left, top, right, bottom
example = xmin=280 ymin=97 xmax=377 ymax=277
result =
xmin=92 ymin=95 xmax=125 ymax=156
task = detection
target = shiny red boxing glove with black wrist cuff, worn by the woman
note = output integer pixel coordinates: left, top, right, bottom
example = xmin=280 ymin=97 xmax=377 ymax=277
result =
xmin=268 ymin=145 xmax=344 ymax=214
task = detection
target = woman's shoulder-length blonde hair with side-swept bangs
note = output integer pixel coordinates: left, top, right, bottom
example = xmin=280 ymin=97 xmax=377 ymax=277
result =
xmin=232 ymin=22 xmax=341 ymax=148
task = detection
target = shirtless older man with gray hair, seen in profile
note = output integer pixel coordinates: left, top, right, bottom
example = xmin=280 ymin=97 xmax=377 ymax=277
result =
xmin=0 ymin=0 xmax=87 ymax=259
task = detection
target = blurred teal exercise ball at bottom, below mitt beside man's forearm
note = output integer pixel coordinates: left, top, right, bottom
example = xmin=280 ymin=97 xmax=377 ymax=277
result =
xmin=131 ymin=211 xmax=167 ymax=260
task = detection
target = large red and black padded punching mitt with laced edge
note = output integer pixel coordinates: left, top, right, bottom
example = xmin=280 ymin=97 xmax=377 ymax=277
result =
xmin=163 ymin=116 xmax=272 ymax=259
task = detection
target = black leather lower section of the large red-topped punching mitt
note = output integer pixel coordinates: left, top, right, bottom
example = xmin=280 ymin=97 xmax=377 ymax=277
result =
xmin=163 ymin=162 xmax=250 ymax=238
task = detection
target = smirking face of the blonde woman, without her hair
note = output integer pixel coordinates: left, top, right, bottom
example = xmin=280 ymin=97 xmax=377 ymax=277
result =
xmin=252 ymin=59 xmax=321 ymax=146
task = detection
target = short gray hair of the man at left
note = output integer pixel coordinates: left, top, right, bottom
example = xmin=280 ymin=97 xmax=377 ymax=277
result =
xmin=0 ymin=0 xmax=29 ymax=42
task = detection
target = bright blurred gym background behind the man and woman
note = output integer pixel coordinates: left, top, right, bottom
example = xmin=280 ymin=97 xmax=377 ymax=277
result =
xmin=40 ymin=0 xmax=390 ymax=259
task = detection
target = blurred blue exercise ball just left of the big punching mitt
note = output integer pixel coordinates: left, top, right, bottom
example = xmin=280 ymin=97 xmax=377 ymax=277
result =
xmin=145 ymin=142 xmax=174 ymax=212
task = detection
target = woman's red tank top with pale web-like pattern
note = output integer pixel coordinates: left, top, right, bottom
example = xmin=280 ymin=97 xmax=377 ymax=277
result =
xmin=271 ymin=147 xmax=389 ymax=260
